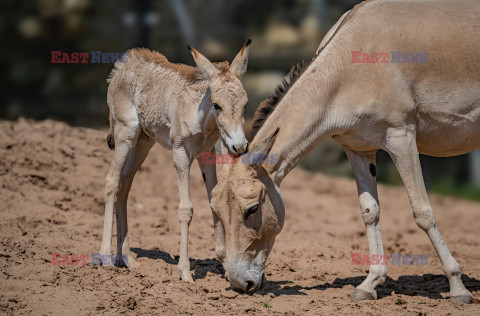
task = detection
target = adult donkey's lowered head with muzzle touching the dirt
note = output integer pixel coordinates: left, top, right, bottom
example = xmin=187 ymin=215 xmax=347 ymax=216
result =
xmin=210 ymin=130 xmax=285 ymax=294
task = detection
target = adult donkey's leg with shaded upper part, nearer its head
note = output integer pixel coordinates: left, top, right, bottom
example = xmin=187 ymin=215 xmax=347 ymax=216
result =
xmin=344 ymin=147 xmax=387 ymax=301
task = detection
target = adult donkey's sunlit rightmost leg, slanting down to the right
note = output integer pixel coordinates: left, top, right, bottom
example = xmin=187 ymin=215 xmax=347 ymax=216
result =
xmin=386 ymin=129 xmax=473 ymax=303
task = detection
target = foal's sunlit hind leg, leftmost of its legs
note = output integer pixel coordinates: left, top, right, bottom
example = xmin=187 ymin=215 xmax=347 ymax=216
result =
xmin=100 ymin=113 xmax=140 ymax=265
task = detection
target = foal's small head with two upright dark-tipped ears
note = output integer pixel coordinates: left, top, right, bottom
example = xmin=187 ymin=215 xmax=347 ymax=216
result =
xmin=188 ymin=39 xmax=252 ymax=154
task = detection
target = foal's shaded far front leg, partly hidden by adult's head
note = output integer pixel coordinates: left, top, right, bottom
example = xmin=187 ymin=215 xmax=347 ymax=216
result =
xmin=197 ymin=147 xmax=228 ymax=279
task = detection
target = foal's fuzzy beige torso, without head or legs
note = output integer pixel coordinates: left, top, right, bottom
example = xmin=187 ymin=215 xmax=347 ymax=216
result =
xmin=107 ymin=48 xmax=228 ymax=148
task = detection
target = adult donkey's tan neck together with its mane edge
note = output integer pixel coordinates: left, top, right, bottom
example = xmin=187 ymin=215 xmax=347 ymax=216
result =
xmin=251 ymin=2 xmax=364 ymax=185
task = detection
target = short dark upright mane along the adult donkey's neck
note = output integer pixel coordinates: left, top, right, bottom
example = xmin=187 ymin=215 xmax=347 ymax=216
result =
xmin=252 ymin=0 xmax=368 ymax=134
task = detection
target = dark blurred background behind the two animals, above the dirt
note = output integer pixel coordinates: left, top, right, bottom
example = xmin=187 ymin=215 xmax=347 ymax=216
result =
xmin=0 ymin=0 xmax=480 ymax=200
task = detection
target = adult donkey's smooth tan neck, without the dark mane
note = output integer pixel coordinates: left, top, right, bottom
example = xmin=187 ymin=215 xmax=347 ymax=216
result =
xmin=251 ymin=48 xmax=344 ymax=185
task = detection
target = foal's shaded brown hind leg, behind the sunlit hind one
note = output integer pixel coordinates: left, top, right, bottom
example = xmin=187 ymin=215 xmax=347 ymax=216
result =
xmin=115 ymin=132 xmax=155 ymax=268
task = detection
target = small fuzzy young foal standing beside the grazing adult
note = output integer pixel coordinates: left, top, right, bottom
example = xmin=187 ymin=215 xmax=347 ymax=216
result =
xmin=100 ymin=40 xmax=251 ymax=282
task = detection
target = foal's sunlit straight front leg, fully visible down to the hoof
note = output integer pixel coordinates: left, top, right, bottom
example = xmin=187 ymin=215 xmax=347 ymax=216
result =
xmin=173 ymin=146 xmax=193 ymax=283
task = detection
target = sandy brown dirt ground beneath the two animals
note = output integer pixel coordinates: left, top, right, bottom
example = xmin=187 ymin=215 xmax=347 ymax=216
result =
xmin=0 ymin=119 xmax=480 ymax=315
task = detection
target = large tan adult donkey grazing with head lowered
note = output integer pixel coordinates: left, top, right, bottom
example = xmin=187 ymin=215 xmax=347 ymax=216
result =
xmin=211 ymin=0 xmax=480 ymax=302
